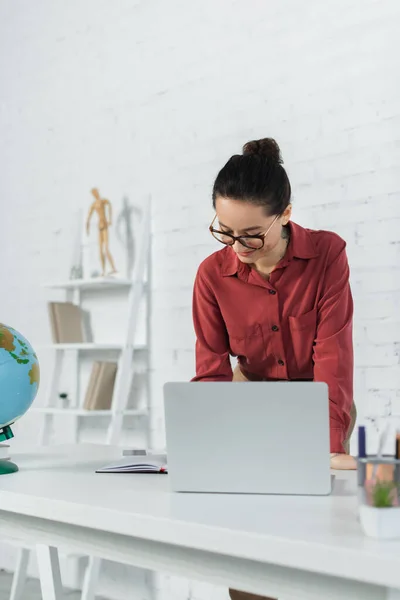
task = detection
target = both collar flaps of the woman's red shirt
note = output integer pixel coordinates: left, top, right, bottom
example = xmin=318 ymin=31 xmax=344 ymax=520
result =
xmin=221 ymin=221 xmax=318 ymax=277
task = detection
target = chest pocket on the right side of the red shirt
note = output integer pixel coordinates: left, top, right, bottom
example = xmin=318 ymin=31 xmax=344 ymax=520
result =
xmin=289 ymin=309 xmax=317 ymax=375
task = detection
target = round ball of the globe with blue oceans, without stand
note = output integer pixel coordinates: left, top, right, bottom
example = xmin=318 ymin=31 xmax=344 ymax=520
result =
xmin=0 ymin=323 xmax=40 ymax=429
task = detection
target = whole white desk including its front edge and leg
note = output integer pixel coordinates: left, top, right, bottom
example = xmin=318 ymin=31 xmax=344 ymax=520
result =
xmin=0 ymin=445 xmax=400 ymax=600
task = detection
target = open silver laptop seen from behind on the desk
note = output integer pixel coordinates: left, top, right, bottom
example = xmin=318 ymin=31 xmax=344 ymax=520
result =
xmin=164 ymin=382 xmax=331 ymax=495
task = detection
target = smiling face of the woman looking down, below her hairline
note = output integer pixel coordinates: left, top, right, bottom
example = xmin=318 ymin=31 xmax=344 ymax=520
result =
xmin=214 ymin=196 xmax=292 ymax=263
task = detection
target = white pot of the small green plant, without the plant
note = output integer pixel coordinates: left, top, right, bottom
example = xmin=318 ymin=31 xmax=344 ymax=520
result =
xmin=360 ymin=504 xmax=400 ymax=540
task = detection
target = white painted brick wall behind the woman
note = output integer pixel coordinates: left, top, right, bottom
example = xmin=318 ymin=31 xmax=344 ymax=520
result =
xmin=0 ymin=0 xmax=400 ymax=600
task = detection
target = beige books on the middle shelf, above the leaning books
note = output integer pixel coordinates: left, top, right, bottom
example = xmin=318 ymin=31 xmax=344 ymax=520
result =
xmin=48 ymin=302 xmax=84 ymax=344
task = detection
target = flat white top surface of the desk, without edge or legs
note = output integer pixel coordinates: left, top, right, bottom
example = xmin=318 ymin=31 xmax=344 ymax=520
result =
xmin=0 ymin=444 xmax=400 ymax=587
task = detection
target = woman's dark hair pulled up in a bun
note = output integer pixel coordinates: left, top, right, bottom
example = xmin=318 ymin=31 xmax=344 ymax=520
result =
xmin=212 ymin=138 xmax=291 ymax=215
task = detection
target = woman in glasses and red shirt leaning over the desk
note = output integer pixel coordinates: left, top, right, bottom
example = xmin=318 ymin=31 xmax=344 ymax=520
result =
xmin=193 ymin=138 xmax=356 ymax=600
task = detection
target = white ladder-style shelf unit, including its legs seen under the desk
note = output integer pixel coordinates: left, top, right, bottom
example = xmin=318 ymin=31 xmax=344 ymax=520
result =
xmin=10 ymin=201 xmax=151 ymax=600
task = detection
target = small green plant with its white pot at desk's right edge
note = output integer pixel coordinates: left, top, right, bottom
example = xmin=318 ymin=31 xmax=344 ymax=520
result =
xmin=360 ymin=479 xmax=400 ymax=539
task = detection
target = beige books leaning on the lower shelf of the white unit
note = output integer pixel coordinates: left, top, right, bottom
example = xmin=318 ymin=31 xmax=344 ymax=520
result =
xmin=83 ymin=361 xmax=118 ymax=410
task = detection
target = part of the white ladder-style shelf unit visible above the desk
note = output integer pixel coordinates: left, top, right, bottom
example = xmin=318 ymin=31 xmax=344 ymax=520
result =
xmin=37 ymin=203 xmax=151 ymax=444
